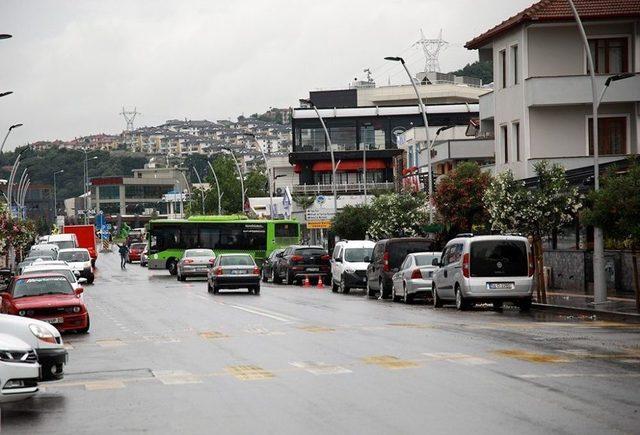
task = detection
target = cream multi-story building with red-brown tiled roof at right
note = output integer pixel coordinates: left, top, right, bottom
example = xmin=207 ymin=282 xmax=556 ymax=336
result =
xmin=466 ymin=0 xmax=640 ymax=178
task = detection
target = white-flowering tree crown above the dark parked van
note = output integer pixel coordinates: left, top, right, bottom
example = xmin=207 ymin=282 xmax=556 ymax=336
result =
xmin=368 ymin=192 xmax=429 ymax=240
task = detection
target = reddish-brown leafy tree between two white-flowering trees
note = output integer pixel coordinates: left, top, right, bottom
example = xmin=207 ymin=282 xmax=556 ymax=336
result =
xmin=433 ymin=162 xmax=491 ymax=234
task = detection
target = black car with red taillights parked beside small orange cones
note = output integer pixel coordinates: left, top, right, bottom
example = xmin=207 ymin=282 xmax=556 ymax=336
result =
xmin=274 ymin=245 xmax=331 ymax=284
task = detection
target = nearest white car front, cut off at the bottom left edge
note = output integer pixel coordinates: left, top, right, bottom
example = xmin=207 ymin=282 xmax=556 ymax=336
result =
xmin=0 ymin=333 xmax=40 ymax=403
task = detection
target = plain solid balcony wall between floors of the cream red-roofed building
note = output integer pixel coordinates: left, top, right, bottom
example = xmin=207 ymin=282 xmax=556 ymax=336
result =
xmin=525 ymin=75 xmax=640 ymax=107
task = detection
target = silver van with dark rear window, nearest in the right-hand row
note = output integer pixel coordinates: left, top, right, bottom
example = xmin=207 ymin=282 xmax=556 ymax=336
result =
xmin=433 ymin=236 xmax=535 ymax=311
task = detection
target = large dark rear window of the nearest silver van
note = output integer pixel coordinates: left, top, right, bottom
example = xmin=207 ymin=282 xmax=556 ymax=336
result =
xmin=470 ymin=240 xmax=529 ymax=277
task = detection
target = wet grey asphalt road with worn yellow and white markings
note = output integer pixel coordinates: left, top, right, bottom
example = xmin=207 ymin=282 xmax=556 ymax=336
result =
xmin=1 ymin=250 xmax=640 ymax=434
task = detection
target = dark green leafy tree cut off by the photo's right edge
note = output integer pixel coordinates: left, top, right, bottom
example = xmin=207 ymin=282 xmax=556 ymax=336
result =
xmin=582 ymin=159 xmax=640 ymax=312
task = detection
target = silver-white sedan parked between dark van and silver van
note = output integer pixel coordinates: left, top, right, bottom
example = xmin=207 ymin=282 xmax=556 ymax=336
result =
xmin=391 ymin=252 xmax=442 ymax=304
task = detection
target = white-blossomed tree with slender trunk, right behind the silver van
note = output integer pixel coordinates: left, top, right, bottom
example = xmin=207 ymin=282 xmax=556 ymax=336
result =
xmin=484 ymin=160 xmax=581 ymax=303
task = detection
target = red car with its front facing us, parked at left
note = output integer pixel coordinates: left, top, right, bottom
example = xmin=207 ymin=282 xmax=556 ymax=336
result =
xmin=0 ymin=273 xmax=90 ymax=333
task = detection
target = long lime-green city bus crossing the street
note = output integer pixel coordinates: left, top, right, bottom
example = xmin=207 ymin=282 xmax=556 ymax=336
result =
xmin=148 ymin=215 xmax=300 ymax=275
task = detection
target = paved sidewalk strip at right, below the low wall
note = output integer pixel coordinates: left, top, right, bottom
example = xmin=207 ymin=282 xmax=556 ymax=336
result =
xmin=534 ymin=289 xmax=640 ymax=321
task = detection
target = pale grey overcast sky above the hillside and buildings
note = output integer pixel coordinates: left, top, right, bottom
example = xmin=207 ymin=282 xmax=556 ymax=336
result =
xmin=0 ymin=0 xmax=532 ymax=149
